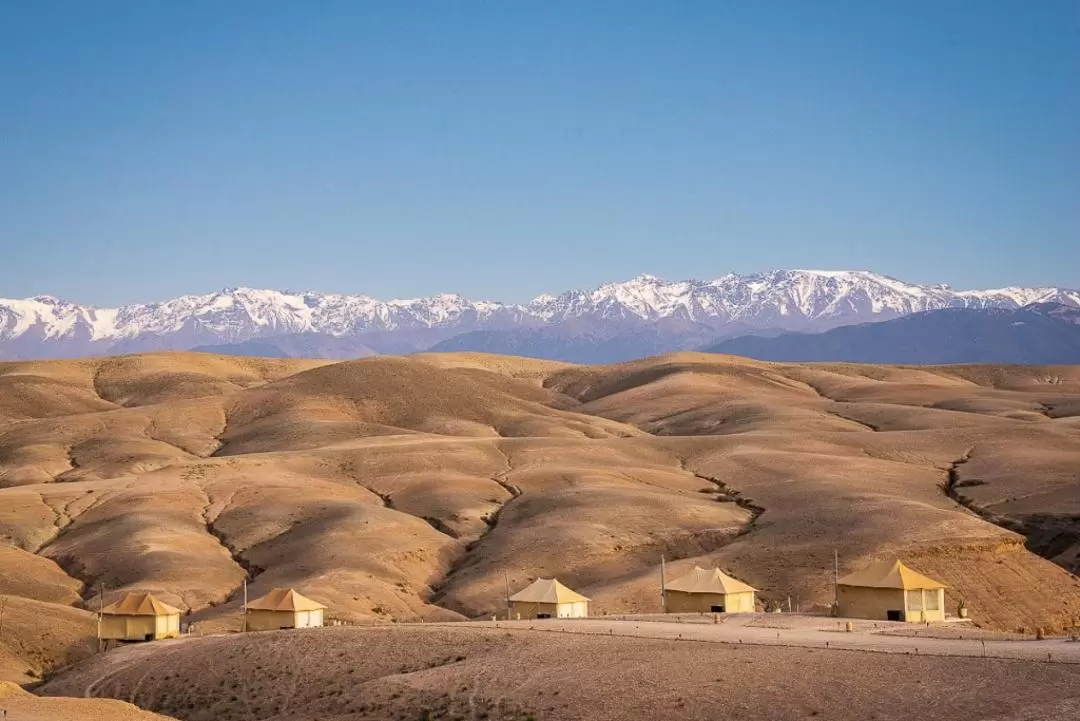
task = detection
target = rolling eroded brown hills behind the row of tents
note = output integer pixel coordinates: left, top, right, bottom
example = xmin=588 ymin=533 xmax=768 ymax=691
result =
xmin=0 ymin=353 xmax=1080 ymax=680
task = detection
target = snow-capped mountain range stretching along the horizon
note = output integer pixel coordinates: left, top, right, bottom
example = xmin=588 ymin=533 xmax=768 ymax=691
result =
xmin=0 ymin=270 xmax=1080 ymax=358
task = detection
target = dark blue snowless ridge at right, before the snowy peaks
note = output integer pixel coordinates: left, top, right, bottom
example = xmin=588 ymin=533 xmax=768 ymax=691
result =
xmin=706 ymin=303 xmax=1080 ymax=365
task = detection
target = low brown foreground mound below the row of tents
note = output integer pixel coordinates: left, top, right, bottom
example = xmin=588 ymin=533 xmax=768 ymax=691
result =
xmin=41 ymin=622 xmax=1080 ymax=721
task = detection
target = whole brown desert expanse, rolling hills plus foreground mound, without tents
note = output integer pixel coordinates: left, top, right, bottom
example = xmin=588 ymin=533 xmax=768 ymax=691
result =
xmin=0 ymin=353 xmax=1080 ymax=721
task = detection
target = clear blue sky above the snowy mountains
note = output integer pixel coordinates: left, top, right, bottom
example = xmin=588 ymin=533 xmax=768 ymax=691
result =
xmin=0 ymin=0 xmax=1080 ymax=304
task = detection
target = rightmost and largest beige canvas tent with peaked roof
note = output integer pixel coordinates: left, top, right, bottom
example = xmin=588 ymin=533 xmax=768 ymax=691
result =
xmin=837 ymin=560 xmax=945 ymax=623
